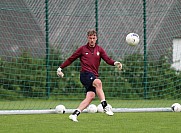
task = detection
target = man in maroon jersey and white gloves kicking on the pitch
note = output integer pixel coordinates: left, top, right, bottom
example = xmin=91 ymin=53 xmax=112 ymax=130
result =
xmin=57 ymin=30 xmax=122 ymax=122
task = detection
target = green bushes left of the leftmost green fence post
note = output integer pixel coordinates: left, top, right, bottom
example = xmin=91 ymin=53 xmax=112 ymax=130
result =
xmin=1 ymin=51 xmax=46 ymax=97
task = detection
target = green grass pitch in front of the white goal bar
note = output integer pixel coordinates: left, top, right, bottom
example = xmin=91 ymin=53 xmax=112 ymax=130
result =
xmin=0 ymin=112 xmax=181 ymax=133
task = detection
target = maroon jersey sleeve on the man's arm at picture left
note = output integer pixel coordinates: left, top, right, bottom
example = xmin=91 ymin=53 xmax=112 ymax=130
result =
xmin=60 ymin=47 xmax=82 ymax=69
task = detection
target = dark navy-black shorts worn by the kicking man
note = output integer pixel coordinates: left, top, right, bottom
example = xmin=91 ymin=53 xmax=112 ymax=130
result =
xmin=80 ymin=71 xmax=96 ymax=93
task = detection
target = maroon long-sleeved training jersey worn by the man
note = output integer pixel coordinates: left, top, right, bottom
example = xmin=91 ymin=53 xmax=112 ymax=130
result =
xmin=60 ymin=44 xmax=115 ymax=77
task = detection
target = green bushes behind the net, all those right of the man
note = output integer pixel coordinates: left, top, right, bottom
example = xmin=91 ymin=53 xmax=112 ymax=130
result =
xmin=100 ymin=53 xmax=181 ymax=99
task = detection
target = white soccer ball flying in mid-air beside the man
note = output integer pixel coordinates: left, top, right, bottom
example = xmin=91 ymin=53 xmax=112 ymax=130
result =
xmin=126 ymin=33 xmax=140 ymax=46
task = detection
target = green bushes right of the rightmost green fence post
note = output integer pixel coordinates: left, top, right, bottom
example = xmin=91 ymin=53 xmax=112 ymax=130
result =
xmin=148 ymin=56 xmax=181 ymax=99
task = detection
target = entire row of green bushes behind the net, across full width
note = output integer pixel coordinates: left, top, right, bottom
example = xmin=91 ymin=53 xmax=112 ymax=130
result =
xmin=0 ymin=49 xmax=181 ymax=99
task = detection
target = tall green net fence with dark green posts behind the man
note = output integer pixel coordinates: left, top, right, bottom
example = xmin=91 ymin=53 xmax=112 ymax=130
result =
xmin=0 ymin=0 xmax=181 ymax=110
